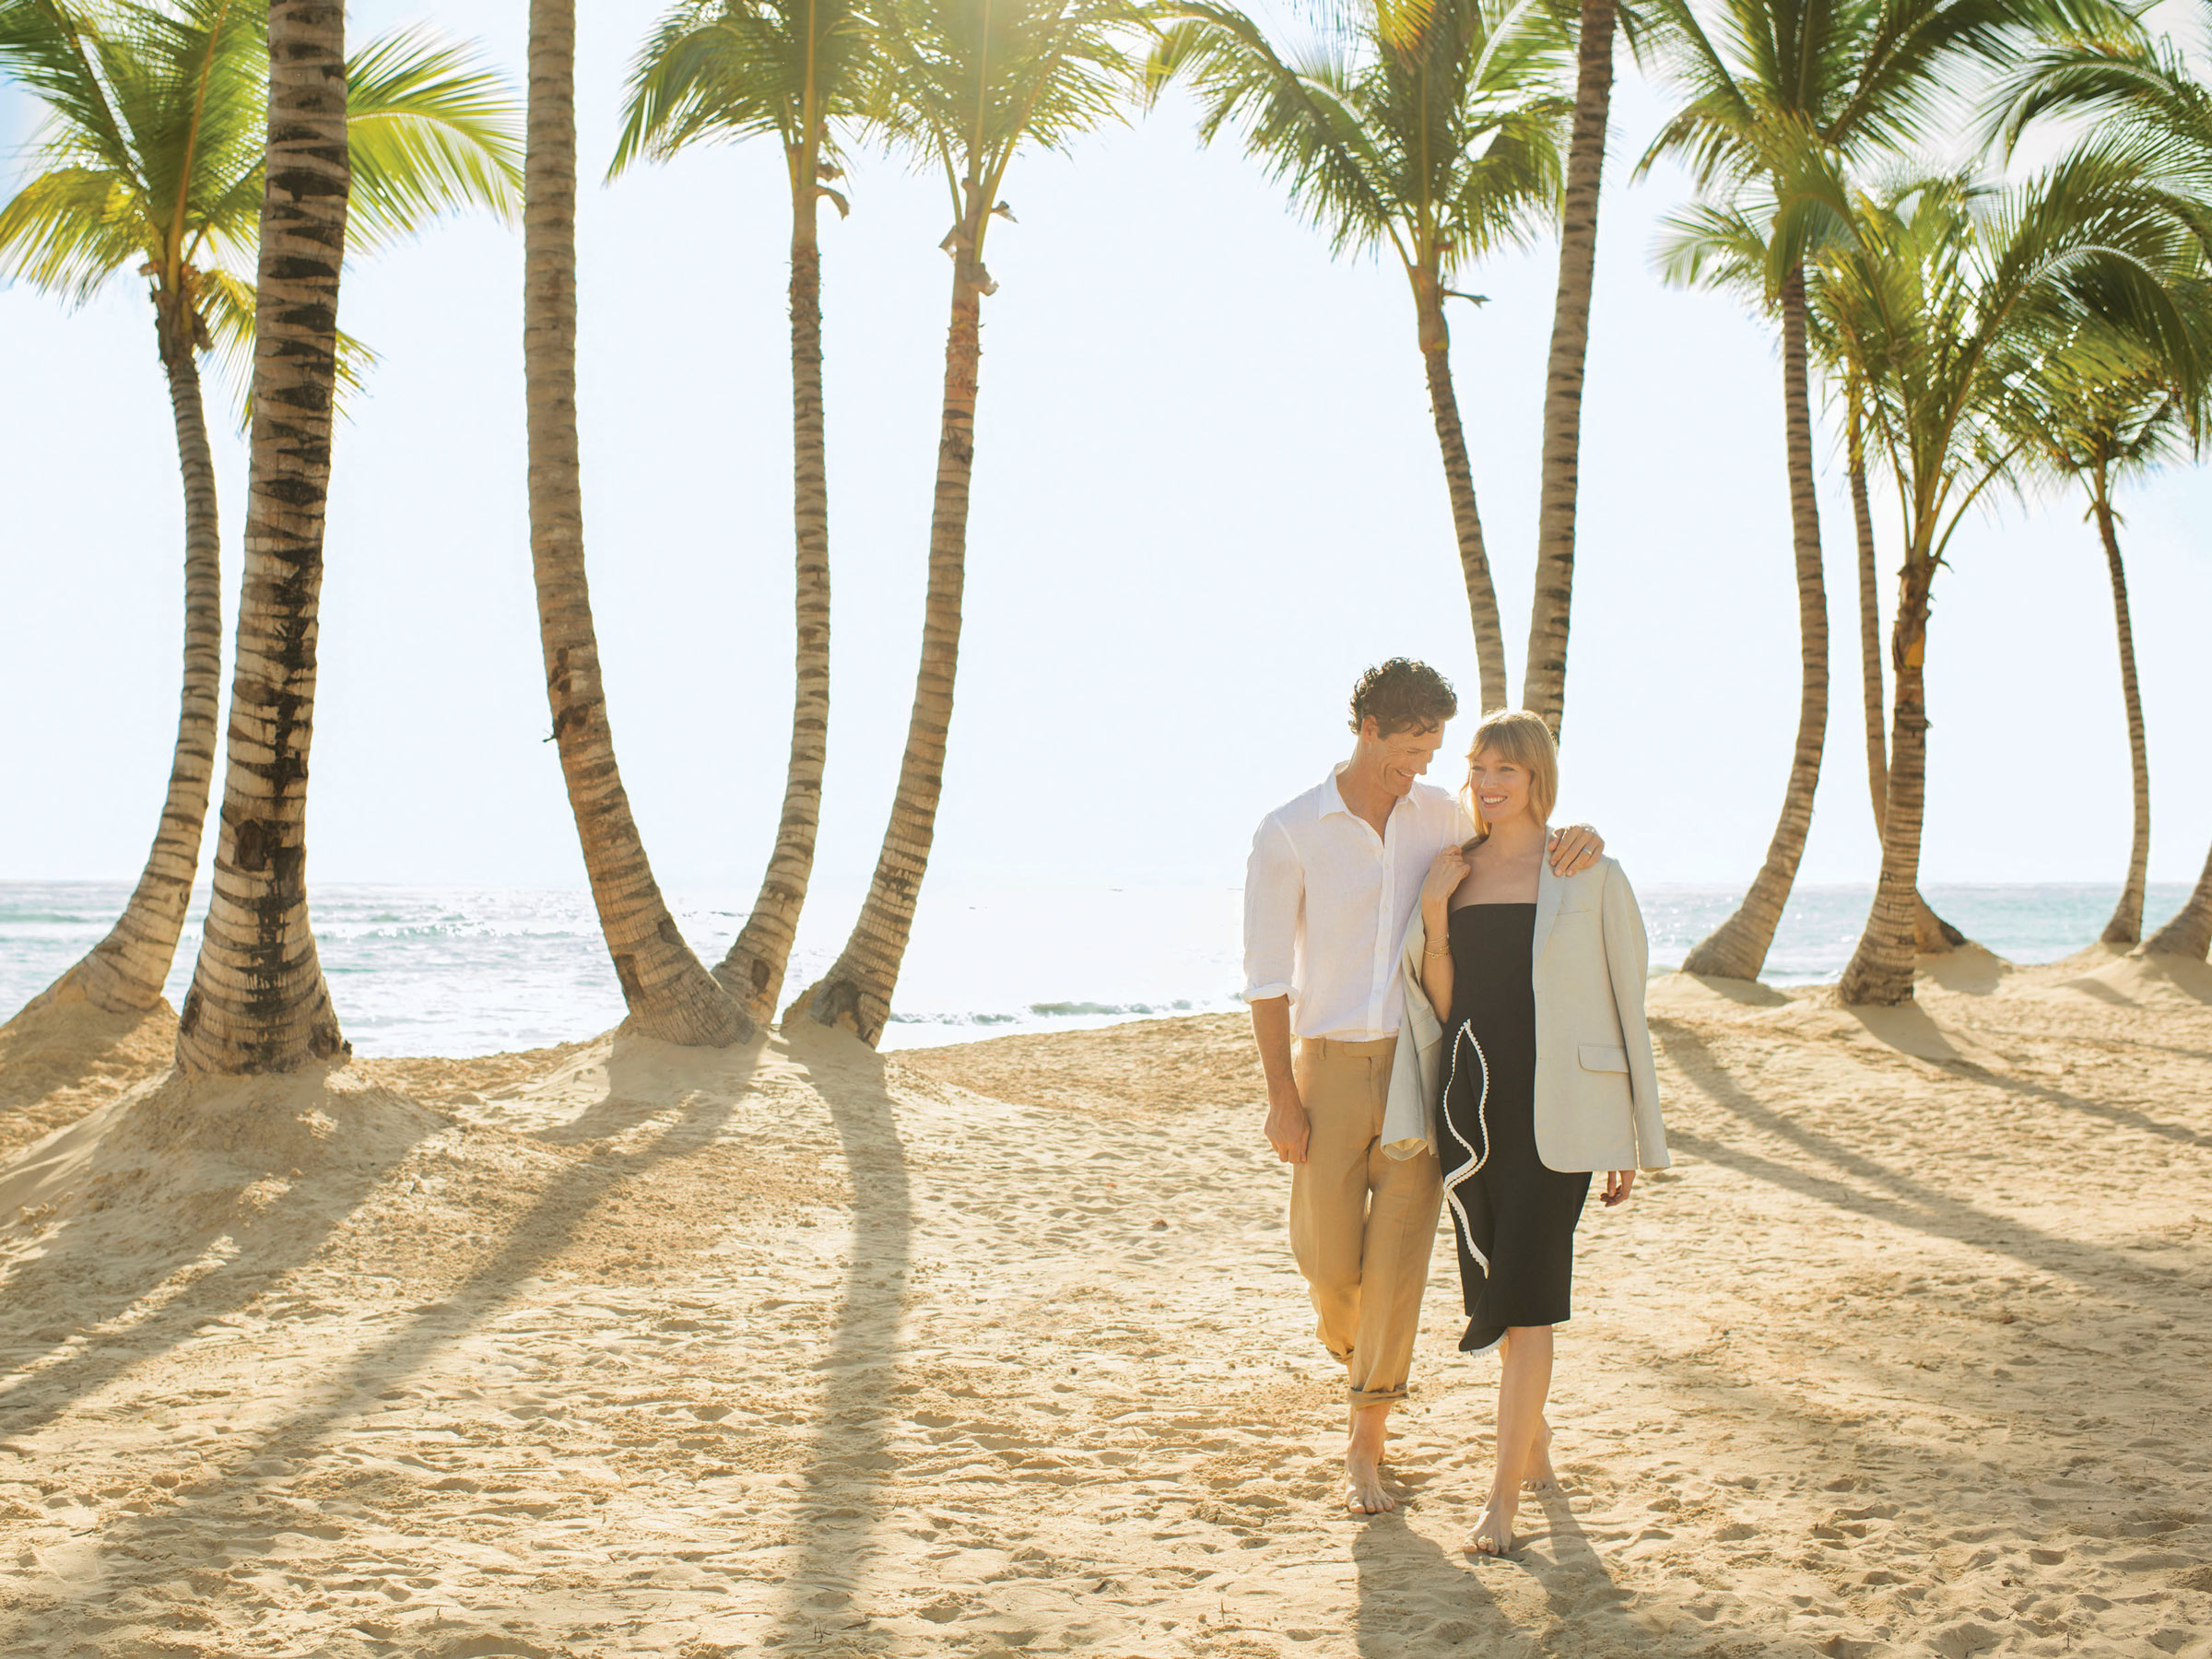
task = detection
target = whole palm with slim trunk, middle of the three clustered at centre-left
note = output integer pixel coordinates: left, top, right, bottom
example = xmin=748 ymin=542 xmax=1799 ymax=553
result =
xmin=610 ymin=0 xmax=869 ymax=1022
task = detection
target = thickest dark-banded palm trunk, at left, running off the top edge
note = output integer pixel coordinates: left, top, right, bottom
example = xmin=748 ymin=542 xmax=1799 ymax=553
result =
xmin=177 ymin=0 xmax=352 ymax=1073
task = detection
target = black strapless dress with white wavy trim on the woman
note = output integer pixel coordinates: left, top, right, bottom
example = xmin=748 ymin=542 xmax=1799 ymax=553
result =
xmin=1438 ymin=905 xmax=1591 ymax=1354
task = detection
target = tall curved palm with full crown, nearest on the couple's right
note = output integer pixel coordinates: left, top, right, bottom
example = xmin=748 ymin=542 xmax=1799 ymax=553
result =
xmin=1637 ymin=0 xmax=2124 ymax=980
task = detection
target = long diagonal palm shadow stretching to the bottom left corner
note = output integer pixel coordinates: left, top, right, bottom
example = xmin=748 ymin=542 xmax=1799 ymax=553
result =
xmin=0 ymin=1035 xmax=759 ymax=1653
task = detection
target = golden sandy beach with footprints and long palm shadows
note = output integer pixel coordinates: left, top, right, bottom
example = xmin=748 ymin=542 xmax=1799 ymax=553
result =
xmin=0 ymin=953 xmax=2212 ymax=1659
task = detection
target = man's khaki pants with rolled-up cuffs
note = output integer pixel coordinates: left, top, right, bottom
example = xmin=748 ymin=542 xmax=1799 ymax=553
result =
xmin=1289 ymin=1038 xmax=1444 ymax=1409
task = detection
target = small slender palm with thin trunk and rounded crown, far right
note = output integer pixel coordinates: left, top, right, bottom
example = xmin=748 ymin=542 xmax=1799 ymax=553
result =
xmin=2002 ymin=325 xmax=2194 ymax=947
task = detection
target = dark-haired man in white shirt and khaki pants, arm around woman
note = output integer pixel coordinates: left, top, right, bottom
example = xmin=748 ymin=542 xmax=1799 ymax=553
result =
xmin=1243 ymin=657 xmax=1604 ymax=1515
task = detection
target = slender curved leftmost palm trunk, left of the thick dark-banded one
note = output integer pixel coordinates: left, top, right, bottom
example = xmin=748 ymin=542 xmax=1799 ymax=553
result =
xmin=33 ymin=303 xmax=223 ymax=1013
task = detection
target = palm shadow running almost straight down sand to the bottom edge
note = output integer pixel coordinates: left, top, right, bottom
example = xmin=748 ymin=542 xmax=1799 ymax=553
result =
xmin=768 ymin=1035 xmax=913 ymax=1653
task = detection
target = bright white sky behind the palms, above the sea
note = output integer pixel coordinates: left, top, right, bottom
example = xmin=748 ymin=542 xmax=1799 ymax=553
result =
xmin=0 ymin=0 xmax=2212 ymax=915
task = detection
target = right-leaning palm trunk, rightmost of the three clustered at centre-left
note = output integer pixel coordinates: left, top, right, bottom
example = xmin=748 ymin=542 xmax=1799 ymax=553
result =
xmin=783 ymin=205 xmax=989 ymax=1046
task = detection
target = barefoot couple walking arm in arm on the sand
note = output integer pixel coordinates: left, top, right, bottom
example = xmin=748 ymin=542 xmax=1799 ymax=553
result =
xmin=1243 ymin=657 xmax=1668 ymax=1555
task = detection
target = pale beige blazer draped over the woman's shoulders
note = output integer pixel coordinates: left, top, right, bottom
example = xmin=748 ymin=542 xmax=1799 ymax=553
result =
xmin=1382 ymin=858 xmax=1668 ymax=1171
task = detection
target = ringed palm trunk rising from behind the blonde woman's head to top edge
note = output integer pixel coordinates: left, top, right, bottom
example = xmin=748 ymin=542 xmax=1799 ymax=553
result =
xmin=1522 ymin=0 xmax=1615 ymax=736
